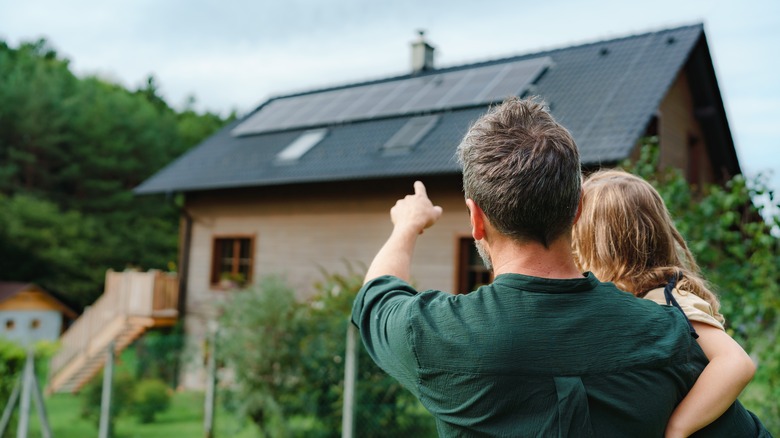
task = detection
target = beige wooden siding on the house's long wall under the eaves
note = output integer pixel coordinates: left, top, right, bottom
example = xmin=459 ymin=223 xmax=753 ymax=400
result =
xmin=183 ymin=176 xmax=471 ymax=387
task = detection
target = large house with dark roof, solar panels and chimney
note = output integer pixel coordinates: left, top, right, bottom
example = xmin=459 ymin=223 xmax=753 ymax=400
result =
xmin=136 ymin=24 xmax=740 ymax=386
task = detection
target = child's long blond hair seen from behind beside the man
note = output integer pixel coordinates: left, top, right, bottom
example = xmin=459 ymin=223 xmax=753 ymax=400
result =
xmin=572 ymin=170 xmax=723 ymax=322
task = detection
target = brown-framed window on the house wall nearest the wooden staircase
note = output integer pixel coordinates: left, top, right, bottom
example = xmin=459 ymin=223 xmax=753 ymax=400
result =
xmin=211 ymin=236 xmax=255 ymax=288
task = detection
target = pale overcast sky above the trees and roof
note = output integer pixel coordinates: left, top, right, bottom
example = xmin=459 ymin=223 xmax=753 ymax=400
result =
xmin=0 ymin=0 xmax=780 ymax=196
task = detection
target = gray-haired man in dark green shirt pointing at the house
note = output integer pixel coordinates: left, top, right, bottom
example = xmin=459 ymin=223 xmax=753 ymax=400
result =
xmin=352 ymin=98 xmax=768 ymax=437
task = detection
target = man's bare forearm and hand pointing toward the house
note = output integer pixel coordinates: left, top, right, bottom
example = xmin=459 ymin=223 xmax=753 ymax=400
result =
xmin=364 ymin=181 xmax=442 ymax=284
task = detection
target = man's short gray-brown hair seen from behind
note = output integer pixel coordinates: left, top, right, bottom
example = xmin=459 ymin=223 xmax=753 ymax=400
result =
xmin=458 ymin=97 xmax=582 ymax=247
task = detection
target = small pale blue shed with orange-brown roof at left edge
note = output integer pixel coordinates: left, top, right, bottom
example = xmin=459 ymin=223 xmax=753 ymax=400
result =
xmin=0 ymin=281 xmax=77 ymax=346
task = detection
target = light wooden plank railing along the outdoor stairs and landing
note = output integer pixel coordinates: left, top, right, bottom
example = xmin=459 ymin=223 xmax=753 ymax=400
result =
xmin=49 ymin=270 xmax=179 ymax=392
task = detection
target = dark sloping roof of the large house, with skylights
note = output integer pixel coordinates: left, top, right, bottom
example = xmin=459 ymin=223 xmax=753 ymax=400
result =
xmin=136 ymin=25 xmax=720 ymax=193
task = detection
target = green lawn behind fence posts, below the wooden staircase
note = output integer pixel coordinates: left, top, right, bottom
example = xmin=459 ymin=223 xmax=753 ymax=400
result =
xmin=21 ymin=392 xmax=260 ymax=438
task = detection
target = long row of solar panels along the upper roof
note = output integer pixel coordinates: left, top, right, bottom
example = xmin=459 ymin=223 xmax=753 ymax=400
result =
xmin=231 ymin=57 xmax=552 ymax=136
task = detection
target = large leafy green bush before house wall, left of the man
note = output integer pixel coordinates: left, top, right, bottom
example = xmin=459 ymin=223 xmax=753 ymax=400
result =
xmin=219 ymin=269 xmax=435 ymax=437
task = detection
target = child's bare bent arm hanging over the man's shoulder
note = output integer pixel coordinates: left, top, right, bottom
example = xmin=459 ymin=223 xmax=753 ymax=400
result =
xmin=665 ymin=321 xmax=756 ymax=438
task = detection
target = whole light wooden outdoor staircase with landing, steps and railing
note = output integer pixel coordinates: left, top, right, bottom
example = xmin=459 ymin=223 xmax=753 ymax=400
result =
xmin=47 ymin=270 xmax=179 ymax=393
